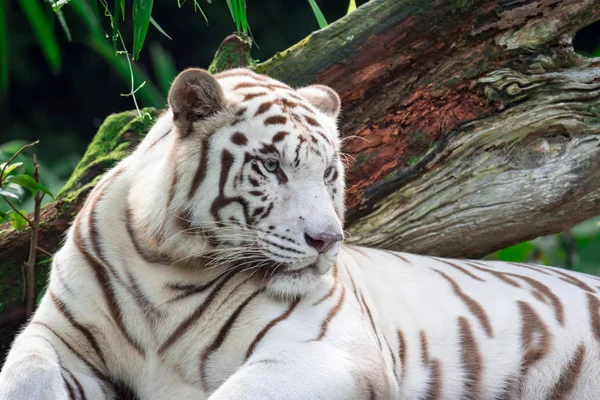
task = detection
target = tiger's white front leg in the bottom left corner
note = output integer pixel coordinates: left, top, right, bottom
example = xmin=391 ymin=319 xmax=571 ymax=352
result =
xmin=0 ymin=324 xmax=106 ymax=400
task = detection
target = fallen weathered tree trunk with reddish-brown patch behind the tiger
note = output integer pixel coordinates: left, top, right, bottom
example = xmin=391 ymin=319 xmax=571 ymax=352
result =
xmin=0 ymin=0 xmax=600 ymax=351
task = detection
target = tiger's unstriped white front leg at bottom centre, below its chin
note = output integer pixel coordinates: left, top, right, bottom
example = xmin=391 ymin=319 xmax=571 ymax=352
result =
xmin=209 ymin=342 xmax=368 ymax=400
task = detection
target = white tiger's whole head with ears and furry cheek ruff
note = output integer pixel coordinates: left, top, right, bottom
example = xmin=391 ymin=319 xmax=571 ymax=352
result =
xmin=129 ymin=69 xmax=344 ymax=295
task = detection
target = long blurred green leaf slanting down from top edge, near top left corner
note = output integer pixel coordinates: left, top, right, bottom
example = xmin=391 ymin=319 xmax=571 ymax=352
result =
xmin=19 ymin=0 xmax=61 ymax=73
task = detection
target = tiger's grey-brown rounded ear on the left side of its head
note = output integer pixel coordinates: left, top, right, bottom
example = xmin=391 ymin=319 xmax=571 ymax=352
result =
xmin=169 ymin=68 xmax=225 ymax=136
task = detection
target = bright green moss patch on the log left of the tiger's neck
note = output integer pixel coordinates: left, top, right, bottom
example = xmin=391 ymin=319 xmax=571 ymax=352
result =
xmin=57 ymin=108 xmax=158 ymax=198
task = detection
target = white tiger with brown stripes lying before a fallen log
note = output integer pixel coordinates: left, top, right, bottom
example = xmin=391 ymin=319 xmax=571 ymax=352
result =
xmin=0 ymin=69 xmax=600 ymax=400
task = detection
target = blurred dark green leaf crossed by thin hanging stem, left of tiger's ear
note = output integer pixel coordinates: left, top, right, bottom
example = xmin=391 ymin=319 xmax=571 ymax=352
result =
xmin=87 ymin=36 xmax=166 ymax=108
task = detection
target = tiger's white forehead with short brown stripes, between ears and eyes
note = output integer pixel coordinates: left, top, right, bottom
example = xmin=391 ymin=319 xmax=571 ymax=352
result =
xmin=215 ymin=70 xmax=339 ymax=167
